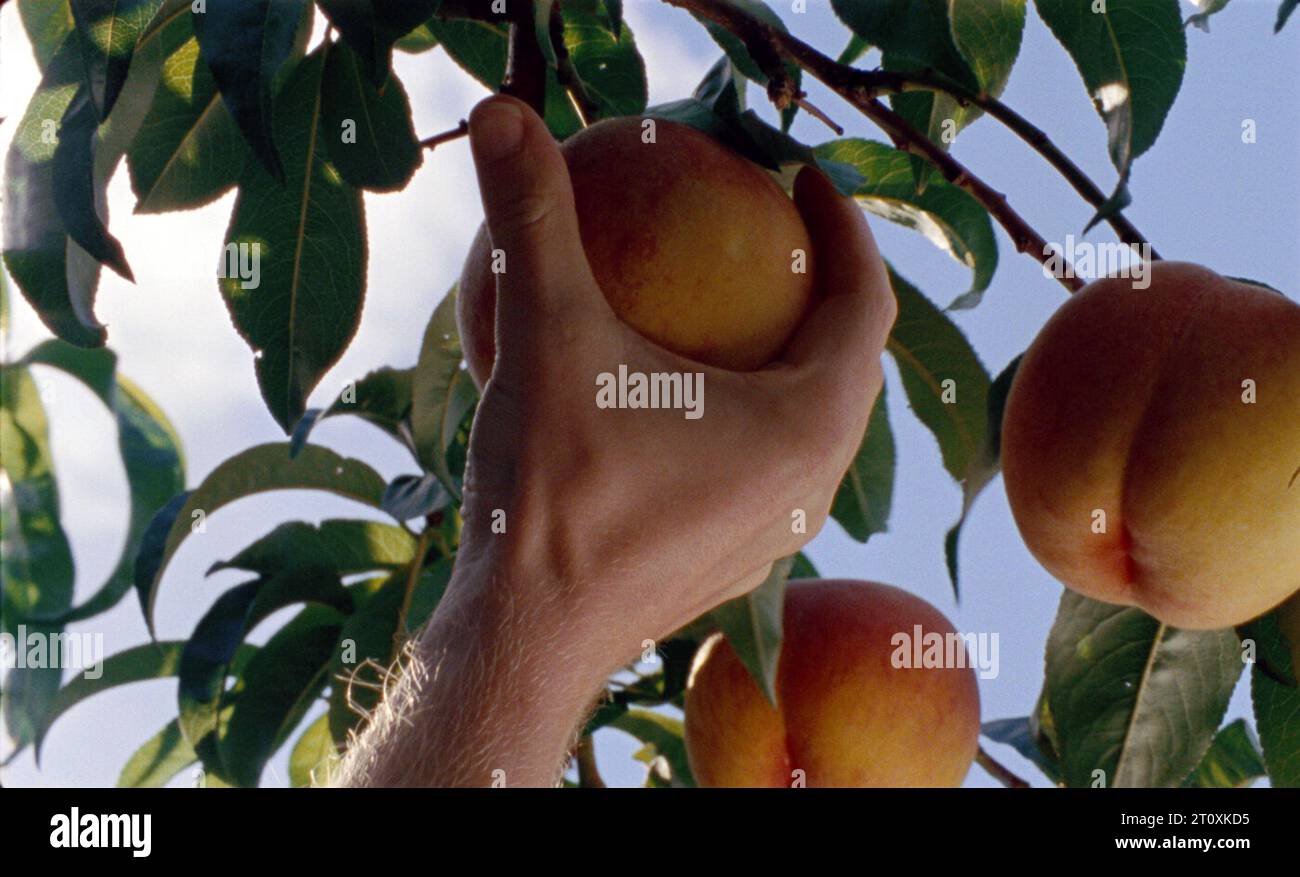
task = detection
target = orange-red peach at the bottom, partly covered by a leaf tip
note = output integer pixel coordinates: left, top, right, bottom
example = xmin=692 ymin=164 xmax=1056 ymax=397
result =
xmin=686 ymin=579 xmax=979 ymax=787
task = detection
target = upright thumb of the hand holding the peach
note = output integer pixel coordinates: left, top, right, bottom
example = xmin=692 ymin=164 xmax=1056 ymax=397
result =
xmin=469 ymin=96 xmax=597 ymax=321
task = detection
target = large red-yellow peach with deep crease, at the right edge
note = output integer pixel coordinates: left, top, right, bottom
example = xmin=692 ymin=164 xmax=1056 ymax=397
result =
xmin=1002 ymin=261 xmax=1300 ymax=629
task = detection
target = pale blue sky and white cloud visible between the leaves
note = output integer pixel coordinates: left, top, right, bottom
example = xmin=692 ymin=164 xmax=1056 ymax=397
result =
xmin=0 ymin=0 xmax=1300 ymax=786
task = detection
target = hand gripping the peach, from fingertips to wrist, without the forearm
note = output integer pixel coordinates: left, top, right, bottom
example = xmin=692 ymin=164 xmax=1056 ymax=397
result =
xmin=463 ymin=97 xmax=896 ymax=678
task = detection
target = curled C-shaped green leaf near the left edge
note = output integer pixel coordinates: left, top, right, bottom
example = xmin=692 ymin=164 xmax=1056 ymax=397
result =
xmin=23 ymin=340 xmax=185 ymax=624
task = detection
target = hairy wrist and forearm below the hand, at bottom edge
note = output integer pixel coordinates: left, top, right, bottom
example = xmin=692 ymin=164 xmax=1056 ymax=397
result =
xmin=335 ymin=564 xmax=607 ymax=787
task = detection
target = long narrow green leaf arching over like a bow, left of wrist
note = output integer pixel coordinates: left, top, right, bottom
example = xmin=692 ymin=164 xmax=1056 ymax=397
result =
xmin=135 ymin=442 xmax=385 ymax=633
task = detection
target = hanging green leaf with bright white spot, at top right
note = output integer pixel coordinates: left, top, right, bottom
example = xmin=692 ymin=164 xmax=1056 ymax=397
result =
xmin=1035 ymin=0 xmax=1187 ymax=180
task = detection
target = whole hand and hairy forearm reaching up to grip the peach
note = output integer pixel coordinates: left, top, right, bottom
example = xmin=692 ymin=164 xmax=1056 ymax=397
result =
xmin=338 ymin=97 xmax=896 ymax=786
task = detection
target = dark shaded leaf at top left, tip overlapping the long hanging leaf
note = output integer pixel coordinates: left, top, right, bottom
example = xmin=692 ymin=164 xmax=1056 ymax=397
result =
xmin=191 ymin=0 xmax=313 ymax=182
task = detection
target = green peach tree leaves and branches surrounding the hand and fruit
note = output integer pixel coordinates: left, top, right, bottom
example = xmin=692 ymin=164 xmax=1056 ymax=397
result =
xmin=0 ymin=0 xmax=1300 ymax=786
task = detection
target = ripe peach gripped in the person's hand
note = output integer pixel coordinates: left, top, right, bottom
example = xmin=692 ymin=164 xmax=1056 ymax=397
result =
xmin=458 ymin=117 xmax=813 ymax=387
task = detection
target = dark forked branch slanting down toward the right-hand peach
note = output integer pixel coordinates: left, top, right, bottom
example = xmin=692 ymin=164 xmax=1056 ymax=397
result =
xmin=666 ymin=0 xmax=1154 ymax=281
